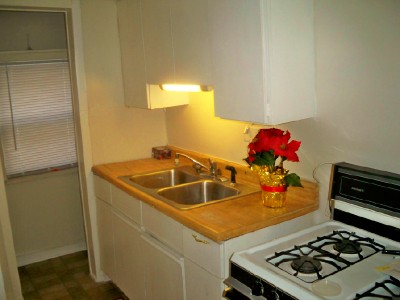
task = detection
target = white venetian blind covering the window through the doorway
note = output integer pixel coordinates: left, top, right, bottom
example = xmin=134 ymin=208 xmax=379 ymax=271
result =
xmin=0 ymin=61 xmax=76 ymax=177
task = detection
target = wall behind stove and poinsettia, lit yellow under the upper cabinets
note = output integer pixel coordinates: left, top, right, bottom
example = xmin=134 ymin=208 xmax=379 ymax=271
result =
xmin=166 ymin=0 xmax=400 ymax=222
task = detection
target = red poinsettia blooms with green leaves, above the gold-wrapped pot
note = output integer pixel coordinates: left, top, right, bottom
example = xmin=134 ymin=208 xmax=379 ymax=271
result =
xmin=244 ymin=128 xmax=302 ymax=187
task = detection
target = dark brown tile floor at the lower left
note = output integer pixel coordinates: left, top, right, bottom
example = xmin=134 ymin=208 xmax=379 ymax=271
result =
xmin=18 ymin=251 xmax=128 ymax=300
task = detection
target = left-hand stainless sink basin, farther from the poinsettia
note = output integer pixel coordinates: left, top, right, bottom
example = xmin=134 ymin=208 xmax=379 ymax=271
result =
xmin=121 ymin=167 xmax=200 ymax=189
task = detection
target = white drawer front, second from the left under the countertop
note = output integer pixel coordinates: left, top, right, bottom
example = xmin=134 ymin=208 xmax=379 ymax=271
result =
xmin=111 ymin=185 xmax=142 ymax=224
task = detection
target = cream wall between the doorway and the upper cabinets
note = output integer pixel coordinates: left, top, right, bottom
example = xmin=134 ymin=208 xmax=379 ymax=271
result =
xmin=81 ymin=0 xmax=167 ymax=164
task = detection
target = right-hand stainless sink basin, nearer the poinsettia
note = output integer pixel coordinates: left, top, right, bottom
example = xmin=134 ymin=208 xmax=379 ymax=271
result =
xmin=158 ymin=180 xmax=240 ymax=206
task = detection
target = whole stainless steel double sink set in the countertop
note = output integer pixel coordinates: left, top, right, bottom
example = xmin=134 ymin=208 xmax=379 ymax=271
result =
xmin=119 ymin=166 xmax=259 ymax=210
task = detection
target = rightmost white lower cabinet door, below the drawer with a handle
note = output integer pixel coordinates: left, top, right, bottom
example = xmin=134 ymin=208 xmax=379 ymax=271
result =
xmin=185 ymin=259 xmax=224 ymax=300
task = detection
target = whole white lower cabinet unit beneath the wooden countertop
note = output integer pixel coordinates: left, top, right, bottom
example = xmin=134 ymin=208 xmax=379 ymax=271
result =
xmin=95 ymin=178 xmax=284 ymax=300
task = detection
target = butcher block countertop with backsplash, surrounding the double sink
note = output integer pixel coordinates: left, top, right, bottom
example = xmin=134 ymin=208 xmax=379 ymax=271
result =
xmin=92 ymin=151 xmax=319 ymax=242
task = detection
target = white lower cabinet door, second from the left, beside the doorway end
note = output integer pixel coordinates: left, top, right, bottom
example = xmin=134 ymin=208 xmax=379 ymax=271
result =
xmin=113 ymin=212 xmax=147 ymax=300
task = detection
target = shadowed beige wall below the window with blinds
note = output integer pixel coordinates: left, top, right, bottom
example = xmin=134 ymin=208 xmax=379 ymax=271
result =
xmin=6 ymin=168 xmax=86 ymax=265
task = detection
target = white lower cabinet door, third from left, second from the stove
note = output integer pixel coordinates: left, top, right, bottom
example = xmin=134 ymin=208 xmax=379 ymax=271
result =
xmin=142 ymin=234 xmax=186 ymax=300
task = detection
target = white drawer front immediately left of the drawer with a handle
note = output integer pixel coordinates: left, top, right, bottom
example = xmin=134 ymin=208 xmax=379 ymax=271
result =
xmin=142 ymin=203 xmax=183 ymax=253
